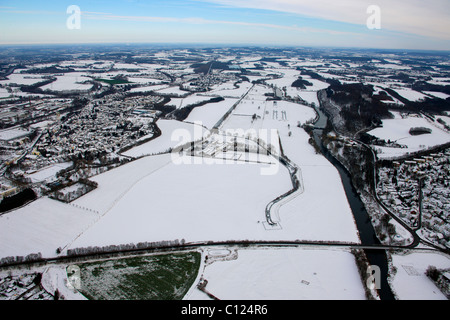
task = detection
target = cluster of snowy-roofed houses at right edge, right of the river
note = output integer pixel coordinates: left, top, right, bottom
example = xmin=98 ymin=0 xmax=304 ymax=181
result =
xmin=377 ymin=149 xmax=450 ymax=247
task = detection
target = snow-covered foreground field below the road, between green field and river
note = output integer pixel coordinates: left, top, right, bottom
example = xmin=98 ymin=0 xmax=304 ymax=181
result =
xmin=184 ymin=248 xmax=365 ymax=300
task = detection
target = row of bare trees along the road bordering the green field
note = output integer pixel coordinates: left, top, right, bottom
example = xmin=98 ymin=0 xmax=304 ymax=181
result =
xmin=67 ymin=239 xmax=186 ymax=257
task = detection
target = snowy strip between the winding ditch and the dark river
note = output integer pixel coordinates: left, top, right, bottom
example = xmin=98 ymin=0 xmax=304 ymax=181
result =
xmin=221 ymin=87 xmax=359 ymax=242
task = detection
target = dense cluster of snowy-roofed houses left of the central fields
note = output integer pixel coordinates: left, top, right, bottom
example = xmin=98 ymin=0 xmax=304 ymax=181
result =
xmin=27 ymin=97 xmax=160 ymax=165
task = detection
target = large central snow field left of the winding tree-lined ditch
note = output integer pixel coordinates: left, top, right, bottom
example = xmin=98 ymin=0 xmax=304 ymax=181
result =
xmin=67 ymin=155 xmax=296 ymax=248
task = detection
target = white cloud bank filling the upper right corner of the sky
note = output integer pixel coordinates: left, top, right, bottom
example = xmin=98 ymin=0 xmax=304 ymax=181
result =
xmin=196 ymin=0 xmax=450 ymax=40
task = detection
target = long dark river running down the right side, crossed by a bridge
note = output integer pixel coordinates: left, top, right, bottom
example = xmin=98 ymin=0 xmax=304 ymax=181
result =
xmin=313 ymin=108 xmax=395 ymax=300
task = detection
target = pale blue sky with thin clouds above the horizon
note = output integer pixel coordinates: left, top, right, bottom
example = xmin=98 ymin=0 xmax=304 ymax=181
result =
xmin=0 ymin=0 xmax=450 ymax=50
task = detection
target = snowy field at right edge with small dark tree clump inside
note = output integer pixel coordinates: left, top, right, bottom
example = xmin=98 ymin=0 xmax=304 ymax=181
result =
xmin=368 ymin=112 xmax=450 ymax=158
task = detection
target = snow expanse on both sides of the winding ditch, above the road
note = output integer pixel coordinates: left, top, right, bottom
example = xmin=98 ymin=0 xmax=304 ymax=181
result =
xmin=63 ymin=83 xmax=359 ymax=248
